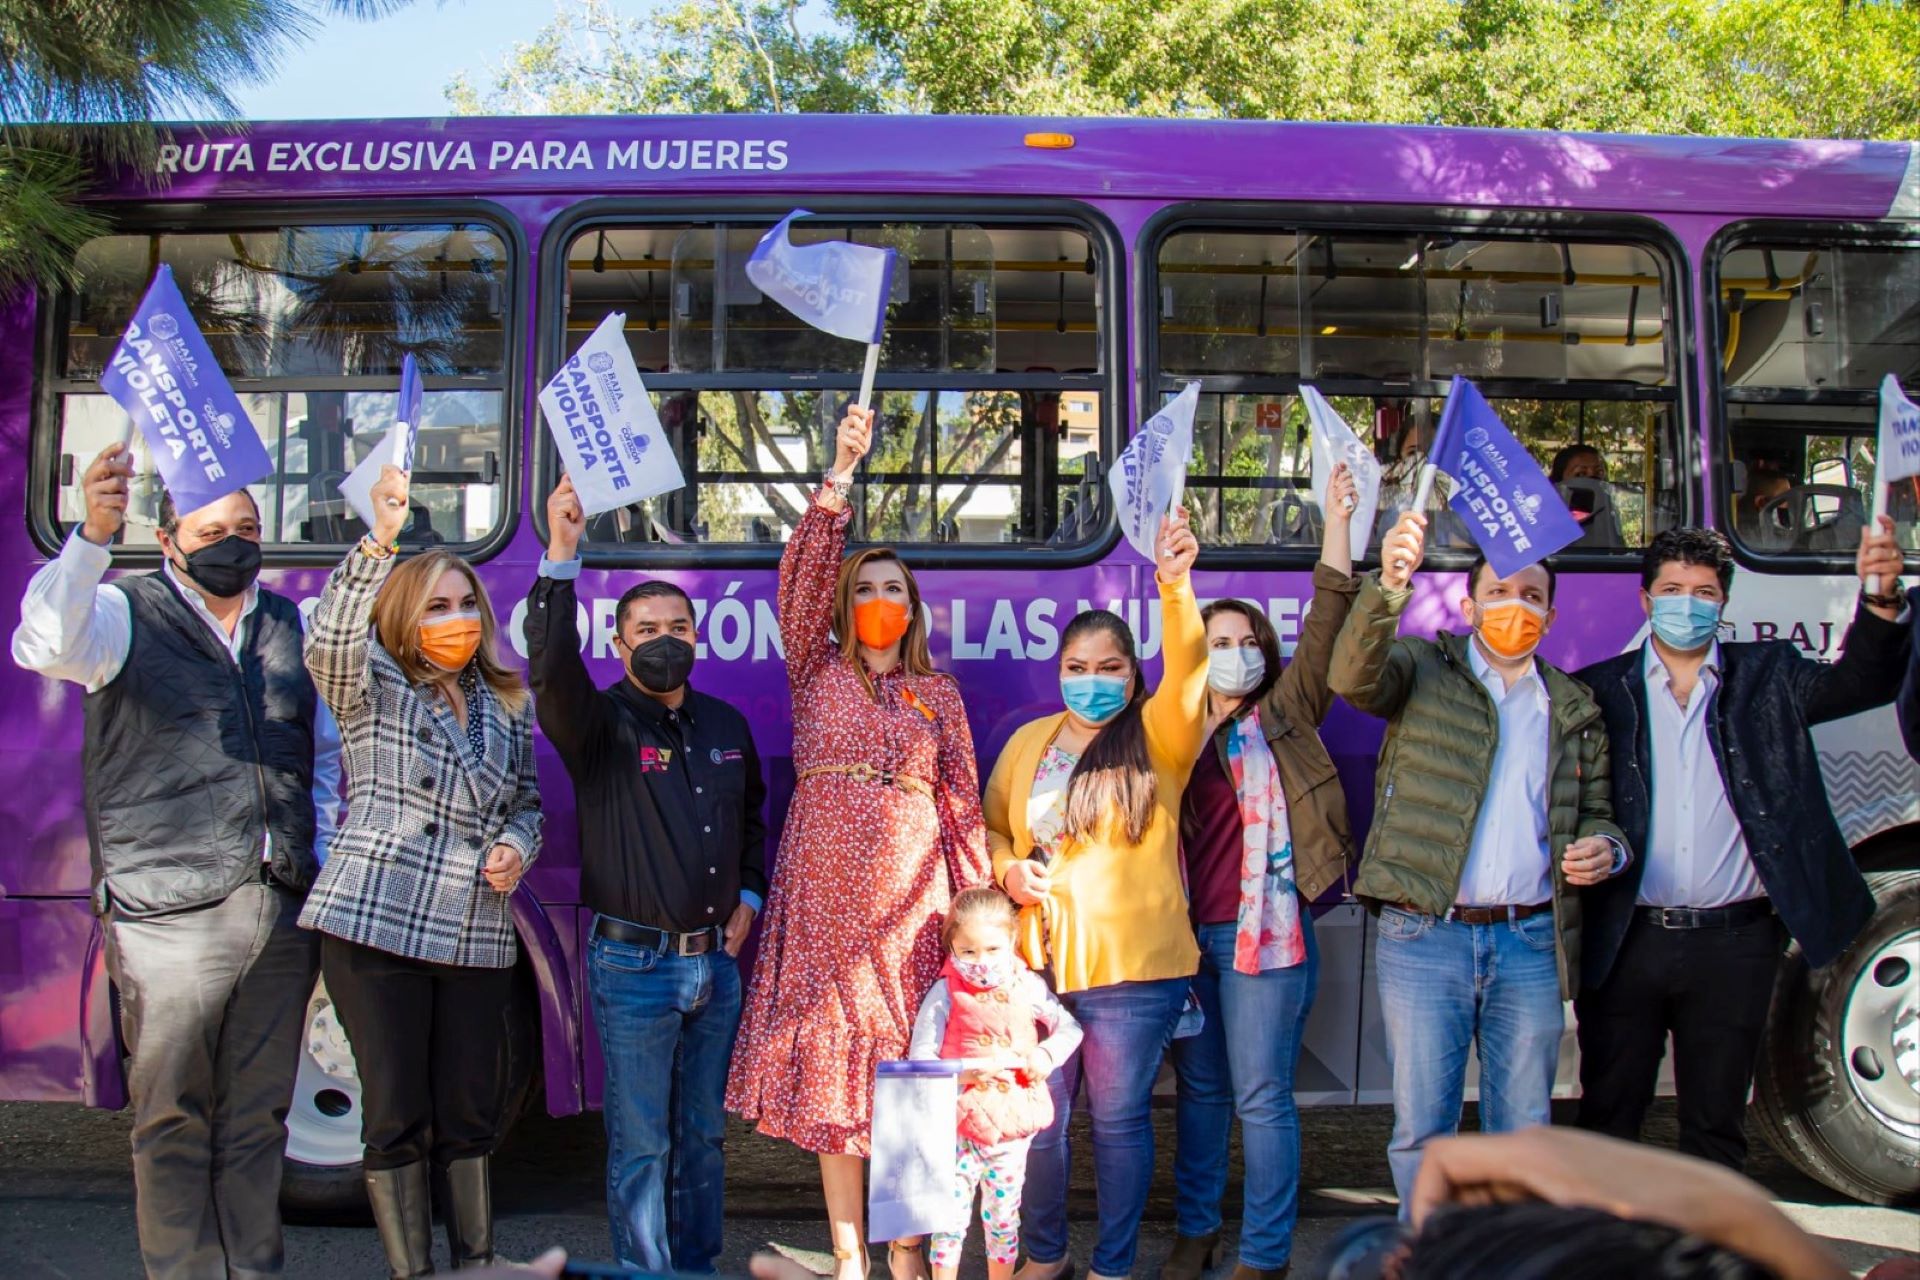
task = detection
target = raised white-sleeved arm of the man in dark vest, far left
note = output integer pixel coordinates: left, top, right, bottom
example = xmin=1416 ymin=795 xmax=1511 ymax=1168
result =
xmin=13 ymin=443 xmax=132 ymax=693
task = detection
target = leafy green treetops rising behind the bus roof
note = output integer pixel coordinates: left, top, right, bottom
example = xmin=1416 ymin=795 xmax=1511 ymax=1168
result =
xmin=449 ymin=0 xmax=1920 ymax=138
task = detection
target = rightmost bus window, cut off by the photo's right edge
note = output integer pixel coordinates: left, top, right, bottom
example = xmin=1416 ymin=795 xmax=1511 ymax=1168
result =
xmin=1720 ymin=240 xmax=1920 ymax=560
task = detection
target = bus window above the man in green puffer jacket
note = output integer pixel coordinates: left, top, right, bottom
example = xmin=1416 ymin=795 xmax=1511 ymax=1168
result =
xmin=1152 ymin=226 xmax=1686 ymax=553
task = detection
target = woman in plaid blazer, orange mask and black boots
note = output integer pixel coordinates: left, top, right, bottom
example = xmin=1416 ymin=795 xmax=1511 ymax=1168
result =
xmin=300 ymin=466 xmax=541 ymax=1276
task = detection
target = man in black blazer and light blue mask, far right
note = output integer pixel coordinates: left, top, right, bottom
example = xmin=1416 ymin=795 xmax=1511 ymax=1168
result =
xmin=1574 ymin=516 xmax=1912 ymax=1169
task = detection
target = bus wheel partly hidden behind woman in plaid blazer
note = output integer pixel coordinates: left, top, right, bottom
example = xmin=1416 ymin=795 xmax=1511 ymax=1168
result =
xmin=280 ymin=963 xmax=540 ymax=1222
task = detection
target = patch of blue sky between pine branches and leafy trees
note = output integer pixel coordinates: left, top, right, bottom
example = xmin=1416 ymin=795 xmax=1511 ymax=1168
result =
xmin=234 ymin=0 xmax=606 ymax=121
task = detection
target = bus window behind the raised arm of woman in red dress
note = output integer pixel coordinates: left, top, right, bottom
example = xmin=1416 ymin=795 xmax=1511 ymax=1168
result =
xmin=566 ymin=217 xmax=1110 ymax=547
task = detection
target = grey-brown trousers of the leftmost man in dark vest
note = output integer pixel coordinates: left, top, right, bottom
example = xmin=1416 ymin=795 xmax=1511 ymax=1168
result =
xmin=106 ymin=883 xmax=315 ymax=1280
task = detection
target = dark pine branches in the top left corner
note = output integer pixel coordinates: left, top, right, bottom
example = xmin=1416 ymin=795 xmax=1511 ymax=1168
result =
xmin=0 ymin=0 xmax=420 ymax=290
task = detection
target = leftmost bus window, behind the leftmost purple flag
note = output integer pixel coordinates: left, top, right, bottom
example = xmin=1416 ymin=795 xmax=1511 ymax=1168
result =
xmin=44 ymin=225 xmax=509 ymax=547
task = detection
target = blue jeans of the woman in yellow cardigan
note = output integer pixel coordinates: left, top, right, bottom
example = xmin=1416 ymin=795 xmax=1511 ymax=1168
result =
xmin=1023 ymin=979 xmax=1192 ymax=1276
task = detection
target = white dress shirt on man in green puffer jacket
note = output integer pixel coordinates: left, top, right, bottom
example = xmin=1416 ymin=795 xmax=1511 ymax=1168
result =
xmin=1453 ymin=639 xmax=1553 ymax=906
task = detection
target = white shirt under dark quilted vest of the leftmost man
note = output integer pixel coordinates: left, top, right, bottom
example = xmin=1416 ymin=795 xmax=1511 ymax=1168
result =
xmin=13 ymin=530 xmax=340 ymax=862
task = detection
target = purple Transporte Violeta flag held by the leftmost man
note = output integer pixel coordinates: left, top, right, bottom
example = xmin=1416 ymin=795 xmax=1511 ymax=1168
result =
xmin=100 ymin=263 xmax=273 ymax=512
